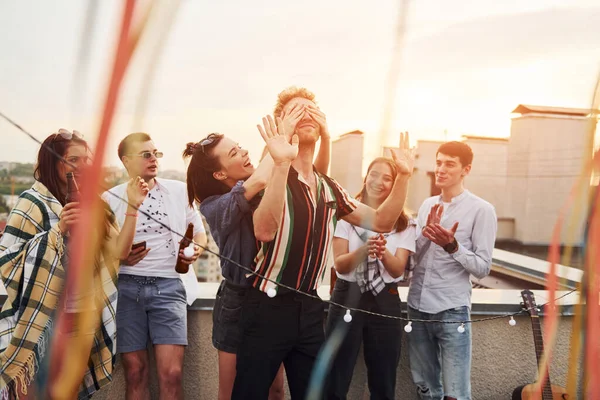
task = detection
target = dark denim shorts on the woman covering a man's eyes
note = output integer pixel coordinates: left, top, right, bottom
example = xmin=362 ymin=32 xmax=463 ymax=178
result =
xmin=213 ymin=281 xmax=248 ymax=354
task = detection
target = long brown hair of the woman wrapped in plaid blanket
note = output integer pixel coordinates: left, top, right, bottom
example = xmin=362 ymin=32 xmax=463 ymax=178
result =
xmin=33 ymin=133 xmax=89 ymax=206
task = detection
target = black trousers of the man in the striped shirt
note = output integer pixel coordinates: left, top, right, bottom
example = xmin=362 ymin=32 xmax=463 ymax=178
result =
xmin=232 ymin=288 xmax=325 ymax=400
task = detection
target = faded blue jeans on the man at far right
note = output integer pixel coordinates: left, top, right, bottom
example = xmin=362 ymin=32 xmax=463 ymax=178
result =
xmin=408 ymin=306 xmax=471 ymax=400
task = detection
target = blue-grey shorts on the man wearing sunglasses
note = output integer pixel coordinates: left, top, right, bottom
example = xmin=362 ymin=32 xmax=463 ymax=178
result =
xmin=117 ymin=274 xmax=187 ymax=353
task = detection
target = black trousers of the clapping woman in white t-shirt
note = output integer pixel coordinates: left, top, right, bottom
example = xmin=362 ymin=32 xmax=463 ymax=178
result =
xmin=325 ymin=278 xmax=403 ymax=400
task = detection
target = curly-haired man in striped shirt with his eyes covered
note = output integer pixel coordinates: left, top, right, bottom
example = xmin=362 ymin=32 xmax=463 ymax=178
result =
xmin=232 ymin=87 xmax=414 ymax=399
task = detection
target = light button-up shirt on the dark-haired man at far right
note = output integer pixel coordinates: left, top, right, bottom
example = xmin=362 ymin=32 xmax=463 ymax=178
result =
xmin=407 ymin=190 xmax=498 ymax=314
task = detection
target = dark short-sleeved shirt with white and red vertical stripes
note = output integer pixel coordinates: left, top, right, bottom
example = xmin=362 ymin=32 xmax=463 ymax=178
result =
xmin=253 ymin=168 xmax=358 ymax=291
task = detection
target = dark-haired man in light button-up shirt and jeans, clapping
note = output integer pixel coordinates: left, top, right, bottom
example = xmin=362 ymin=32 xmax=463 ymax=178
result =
xmin=407 ymin=142 xmax=497 ymax=400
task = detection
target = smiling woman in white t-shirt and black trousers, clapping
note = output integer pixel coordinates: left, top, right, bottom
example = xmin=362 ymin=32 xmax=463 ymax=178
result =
xmin=326 ymin=157 xmax=415 ymax=399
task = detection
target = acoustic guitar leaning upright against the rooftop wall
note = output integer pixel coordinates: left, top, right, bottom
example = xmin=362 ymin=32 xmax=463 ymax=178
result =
xmin=512 ymin=290 xmax=569 ymax=400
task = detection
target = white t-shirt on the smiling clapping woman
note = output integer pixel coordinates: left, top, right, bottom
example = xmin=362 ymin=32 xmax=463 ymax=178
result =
xmin=334 ymin=220 xmax=416 ymax=283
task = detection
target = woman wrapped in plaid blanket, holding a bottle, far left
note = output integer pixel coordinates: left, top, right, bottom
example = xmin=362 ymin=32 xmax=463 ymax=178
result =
xmin=0 ymin=129 xmax=148 ymax=399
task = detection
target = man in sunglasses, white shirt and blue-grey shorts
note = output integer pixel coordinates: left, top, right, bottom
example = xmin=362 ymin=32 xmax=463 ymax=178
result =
xmin=103 ymin=133 xmax=206 ymax=400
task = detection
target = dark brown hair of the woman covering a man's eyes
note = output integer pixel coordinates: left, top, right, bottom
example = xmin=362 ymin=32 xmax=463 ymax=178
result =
xmin=183 ymin=133 xmax=231 ymax=207
